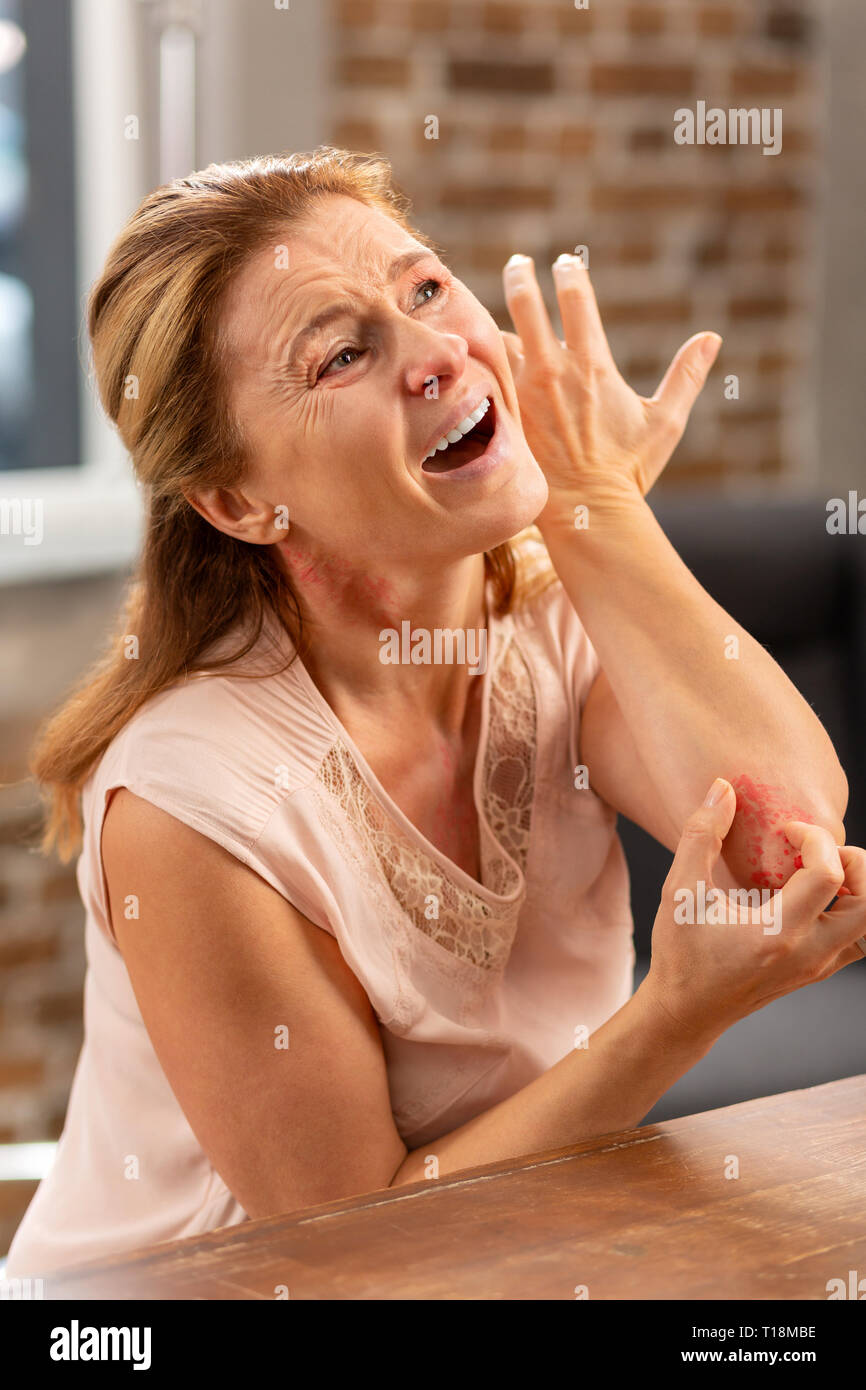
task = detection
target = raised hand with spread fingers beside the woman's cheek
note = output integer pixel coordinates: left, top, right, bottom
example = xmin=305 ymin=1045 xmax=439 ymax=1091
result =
xmin=503 ymin=256 xmax=721 ymax=521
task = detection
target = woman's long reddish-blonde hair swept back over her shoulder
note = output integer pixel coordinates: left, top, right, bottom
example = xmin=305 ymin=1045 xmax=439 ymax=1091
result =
xmin=31 ymin=146 xmax=553 ymax=860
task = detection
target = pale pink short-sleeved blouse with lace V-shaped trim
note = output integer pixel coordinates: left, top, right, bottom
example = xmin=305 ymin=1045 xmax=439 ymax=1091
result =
xmin=6 ymin=561 xmax=634 ymax=1277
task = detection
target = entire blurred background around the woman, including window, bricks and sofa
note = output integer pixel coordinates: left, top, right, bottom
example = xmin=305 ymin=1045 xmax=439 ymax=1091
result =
xmin=0 ymin=0 xmax=866 ymax=1255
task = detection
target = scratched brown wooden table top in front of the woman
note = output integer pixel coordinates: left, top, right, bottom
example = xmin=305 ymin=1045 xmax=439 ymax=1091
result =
xmin=44 ymin=1076 xmax=866 ymax=1300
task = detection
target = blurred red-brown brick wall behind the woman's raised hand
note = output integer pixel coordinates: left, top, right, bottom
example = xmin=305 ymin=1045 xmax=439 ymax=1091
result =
xmin=328 ymin=0 xmax=827 ymax=487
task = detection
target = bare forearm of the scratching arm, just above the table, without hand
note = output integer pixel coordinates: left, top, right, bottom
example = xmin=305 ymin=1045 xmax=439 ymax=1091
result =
xmin=389 ymin=984 xmax=717 ymax=1187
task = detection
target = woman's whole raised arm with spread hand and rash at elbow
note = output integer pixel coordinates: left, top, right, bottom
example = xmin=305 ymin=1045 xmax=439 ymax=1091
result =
xmin=505 ymin=257 xmax=848 ymax=888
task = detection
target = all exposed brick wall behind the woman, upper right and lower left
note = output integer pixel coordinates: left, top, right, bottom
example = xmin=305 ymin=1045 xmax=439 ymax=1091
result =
xmin=0 ymin=0 xmax=826 ymax=1254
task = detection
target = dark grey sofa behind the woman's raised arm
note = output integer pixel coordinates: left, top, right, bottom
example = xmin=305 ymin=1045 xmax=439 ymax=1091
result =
xmin=620 ymin=495 xmax=866 ymax=1122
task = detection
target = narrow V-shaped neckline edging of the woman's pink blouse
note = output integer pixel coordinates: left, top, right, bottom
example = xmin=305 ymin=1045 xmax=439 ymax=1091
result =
xmin=289 ymin=600 xmax=525 ymax=906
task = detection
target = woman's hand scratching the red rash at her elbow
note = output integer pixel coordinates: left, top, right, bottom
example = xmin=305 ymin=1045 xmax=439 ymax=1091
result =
xmin=641 ymin=783 xmax=866 ymax=1038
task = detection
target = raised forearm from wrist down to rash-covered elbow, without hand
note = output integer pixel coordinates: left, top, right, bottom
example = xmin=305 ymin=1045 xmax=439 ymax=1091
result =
xmin=542 ymin=493 xmax=847 ymax=881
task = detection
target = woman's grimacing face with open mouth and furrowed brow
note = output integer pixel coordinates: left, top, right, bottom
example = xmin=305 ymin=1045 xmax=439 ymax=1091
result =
xmin=216 ymin=196 xmax=548 ymax=577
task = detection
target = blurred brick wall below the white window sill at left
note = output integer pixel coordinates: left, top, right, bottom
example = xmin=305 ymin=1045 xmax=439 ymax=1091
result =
xmin=0 ymin=575 xmax=122 ymax=1257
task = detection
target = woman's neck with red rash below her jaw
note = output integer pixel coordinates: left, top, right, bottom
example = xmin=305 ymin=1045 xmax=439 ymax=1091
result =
xmin=277 ymin=534 xmax=487 ymax=734
